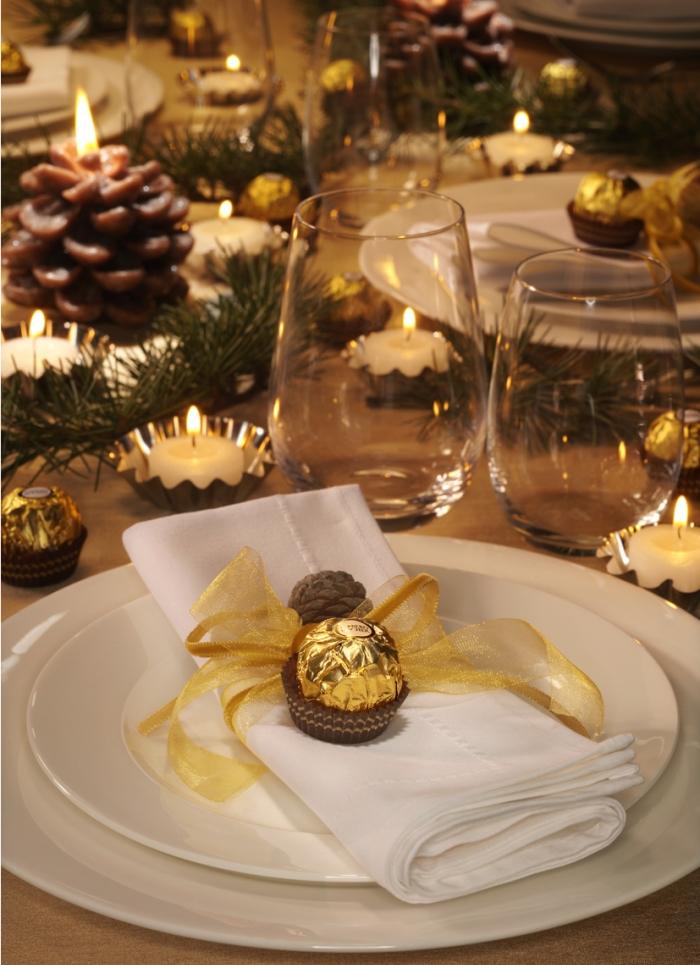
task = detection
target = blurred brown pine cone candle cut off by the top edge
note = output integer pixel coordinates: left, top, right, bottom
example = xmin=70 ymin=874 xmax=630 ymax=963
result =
xmin=393 ymin=0 xmax=513 ymax=79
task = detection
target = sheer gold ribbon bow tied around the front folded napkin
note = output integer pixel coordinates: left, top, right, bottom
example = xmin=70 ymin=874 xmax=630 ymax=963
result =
xmin=139 ymin=548 xmax=603 ymax=801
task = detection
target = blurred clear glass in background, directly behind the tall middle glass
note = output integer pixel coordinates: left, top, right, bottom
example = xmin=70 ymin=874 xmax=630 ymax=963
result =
xmin=303 ymin=8 xmax=443 ymax=191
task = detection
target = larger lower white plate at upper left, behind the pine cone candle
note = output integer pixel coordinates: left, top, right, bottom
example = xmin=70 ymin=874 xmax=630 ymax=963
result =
xmin=3 ymin=53 xmax=163 ymax=154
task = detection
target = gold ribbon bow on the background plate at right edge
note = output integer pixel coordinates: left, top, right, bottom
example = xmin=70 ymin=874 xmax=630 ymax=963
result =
xmin=620 ymin=161 xmax=700 ymax=293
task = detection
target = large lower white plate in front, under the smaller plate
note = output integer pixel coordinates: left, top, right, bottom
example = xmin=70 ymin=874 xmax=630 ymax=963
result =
xmin=3 ymin=536 xmax=700 ymax=951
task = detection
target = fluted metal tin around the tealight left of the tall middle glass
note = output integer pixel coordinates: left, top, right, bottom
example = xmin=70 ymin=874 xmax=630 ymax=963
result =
xmin=107 ymin=416 xmax=274 ymax=513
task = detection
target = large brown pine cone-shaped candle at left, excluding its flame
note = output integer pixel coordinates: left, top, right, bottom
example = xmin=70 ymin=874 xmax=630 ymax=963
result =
xmin=2 ymin=142 xmax=192 ymax=328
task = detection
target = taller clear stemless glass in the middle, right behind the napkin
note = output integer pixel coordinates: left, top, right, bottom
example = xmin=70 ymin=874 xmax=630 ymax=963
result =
xmin=269 ymin=189 xmax=486 ymax=520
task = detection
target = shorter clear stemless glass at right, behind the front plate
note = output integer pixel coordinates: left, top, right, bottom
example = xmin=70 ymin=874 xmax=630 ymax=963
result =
xmin=487 ymin=248 xmax=683 ymax=554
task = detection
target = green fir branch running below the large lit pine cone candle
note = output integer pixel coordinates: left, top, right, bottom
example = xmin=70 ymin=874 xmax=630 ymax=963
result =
xmin=2 ymin=253 xmax=284 ymax=485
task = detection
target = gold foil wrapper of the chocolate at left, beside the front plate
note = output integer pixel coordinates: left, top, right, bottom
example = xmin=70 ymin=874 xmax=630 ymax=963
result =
xmin=2 ymin=486 xmax=82 ymax=557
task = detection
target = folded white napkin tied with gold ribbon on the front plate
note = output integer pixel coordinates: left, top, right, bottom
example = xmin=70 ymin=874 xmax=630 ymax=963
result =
xmin=124 ymin=486 xmax=641 ymax=902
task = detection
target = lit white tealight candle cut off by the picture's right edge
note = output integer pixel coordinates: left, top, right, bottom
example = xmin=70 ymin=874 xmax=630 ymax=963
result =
xmin=616 ymin=496 xmax=700 ymax=593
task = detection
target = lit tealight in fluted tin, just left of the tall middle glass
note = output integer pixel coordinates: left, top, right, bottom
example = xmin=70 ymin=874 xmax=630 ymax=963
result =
xmin=148 ymin=406 xmax=244 ymax=489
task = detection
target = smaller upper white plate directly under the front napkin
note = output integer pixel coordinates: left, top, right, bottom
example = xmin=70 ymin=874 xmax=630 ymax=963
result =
xmin=27 ymin=570 xmax=678 ymax=883
